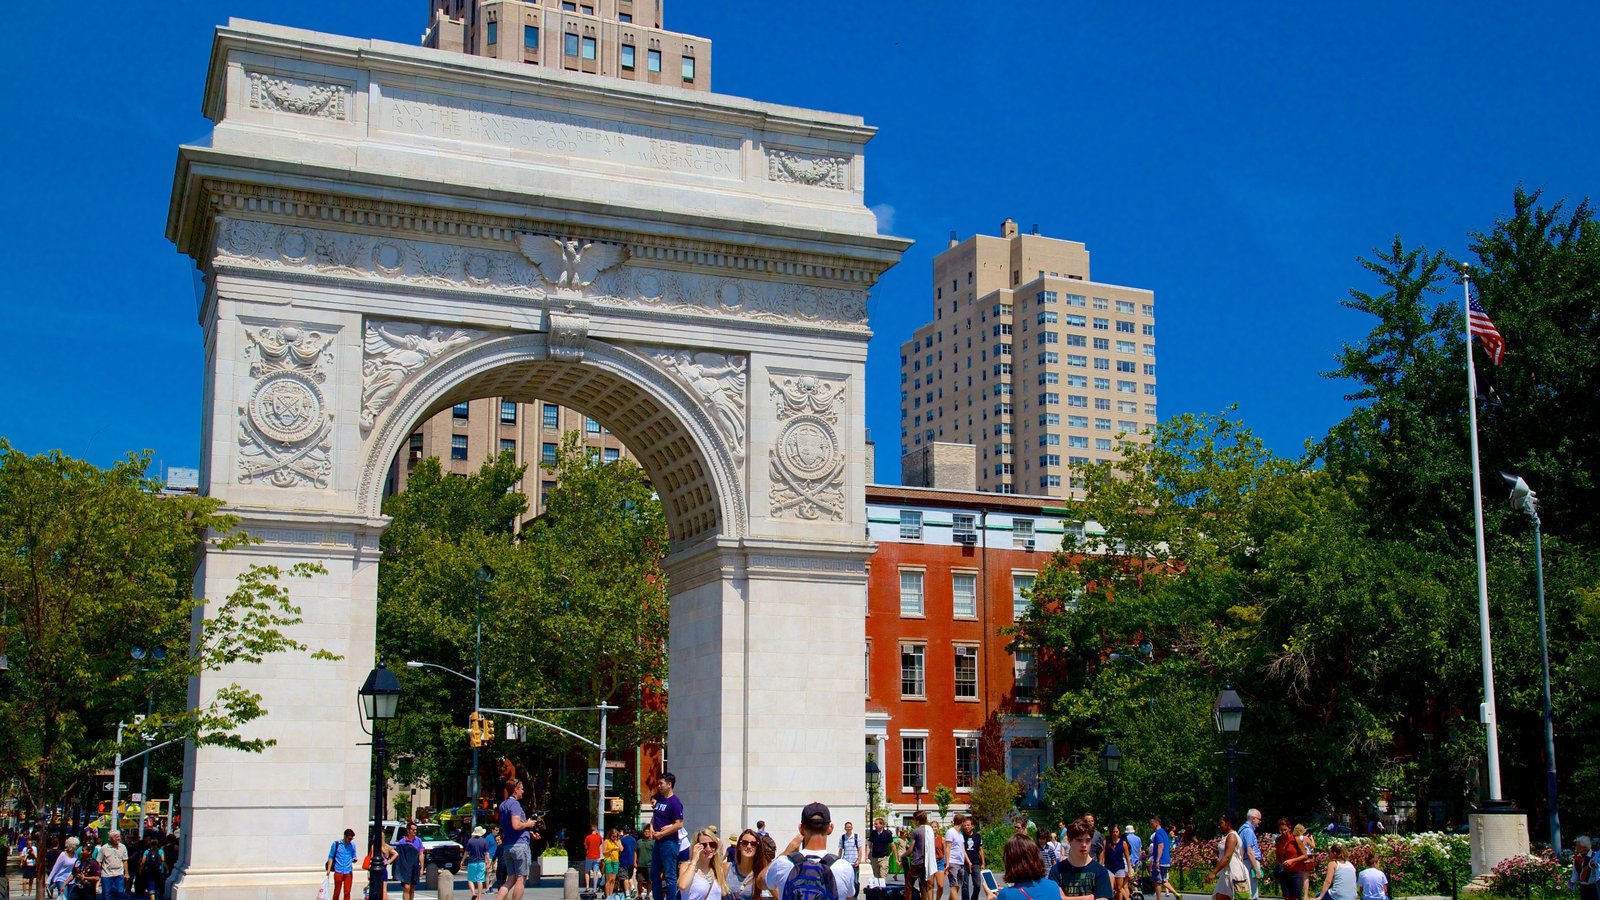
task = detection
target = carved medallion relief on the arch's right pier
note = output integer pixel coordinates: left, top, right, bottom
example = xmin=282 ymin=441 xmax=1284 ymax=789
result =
xmin=770 ymin=375 xmax=845 ymax=522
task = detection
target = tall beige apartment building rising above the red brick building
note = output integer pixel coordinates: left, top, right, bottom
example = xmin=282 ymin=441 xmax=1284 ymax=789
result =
xmin=901 ymin=219 xmax=1157 ymax=498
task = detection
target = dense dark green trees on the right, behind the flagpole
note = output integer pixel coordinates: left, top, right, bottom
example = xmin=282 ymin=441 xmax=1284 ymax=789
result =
xmin=1013 ymin=191 xmax=1600 ymax=831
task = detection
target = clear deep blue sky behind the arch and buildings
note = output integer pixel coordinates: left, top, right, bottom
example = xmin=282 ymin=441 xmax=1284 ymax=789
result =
xmin=0 ymin=0 xmax=1600 ymax=482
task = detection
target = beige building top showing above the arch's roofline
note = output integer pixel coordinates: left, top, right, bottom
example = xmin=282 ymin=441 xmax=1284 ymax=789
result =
xmin=422 ymin=0 xmax=710 ymax=91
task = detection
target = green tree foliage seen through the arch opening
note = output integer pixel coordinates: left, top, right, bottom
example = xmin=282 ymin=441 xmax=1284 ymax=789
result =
xmin=378 ymin=432 xmax=667 ymax=800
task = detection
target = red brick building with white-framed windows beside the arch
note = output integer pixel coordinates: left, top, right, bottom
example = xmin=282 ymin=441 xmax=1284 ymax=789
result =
xmin=866 ymin=485 xmax=1083 ymax=815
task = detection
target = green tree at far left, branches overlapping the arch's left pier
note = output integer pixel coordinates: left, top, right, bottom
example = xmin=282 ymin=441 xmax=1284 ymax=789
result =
xmin=0 ymin=439 xmax=336 ymax=810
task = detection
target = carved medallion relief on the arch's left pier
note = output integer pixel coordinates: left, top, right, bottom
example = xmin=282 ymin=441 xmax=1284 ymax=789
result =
xmin=238 ymin=325 xmax=333 ymax=488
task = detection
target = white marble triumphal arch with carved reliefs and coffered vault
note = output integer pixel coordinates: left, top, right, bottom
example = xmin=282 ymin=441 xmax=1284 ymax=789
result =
xmin=168 ymin=22 xmax=906 ymax=898
